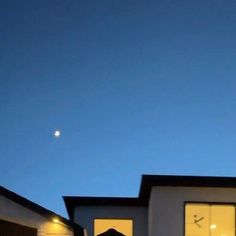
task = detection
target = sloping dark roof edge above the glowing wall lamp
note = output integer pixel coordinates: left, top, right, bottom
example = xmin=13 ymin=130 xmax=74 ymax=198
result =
xmin=0 ymin=186 xmax=83 ymax=235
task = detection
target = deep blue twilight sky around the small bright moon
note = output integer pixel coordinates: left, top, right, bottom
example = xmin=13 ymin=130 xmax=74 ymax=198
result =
xmin=0 ymin=0 xmax=236 ymax=218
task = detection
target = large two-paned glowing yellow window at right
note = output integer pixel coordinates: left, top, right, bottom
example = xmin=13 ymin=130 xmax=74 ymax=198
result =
xmin=185 ymin=203 xmax=235 ymax=236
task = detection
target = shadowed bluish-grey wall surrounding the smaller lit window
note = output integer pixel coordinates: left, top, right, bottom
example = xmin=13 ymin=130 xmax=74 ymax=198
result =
xmin=74 ymin=206 xmax=147 ymax=236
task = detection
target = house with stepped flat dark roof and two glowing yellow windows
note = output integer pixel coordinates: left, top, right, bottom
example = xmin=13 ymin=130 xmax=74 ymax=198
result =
xmin=64 ymin=175 xmax=236 ymax=236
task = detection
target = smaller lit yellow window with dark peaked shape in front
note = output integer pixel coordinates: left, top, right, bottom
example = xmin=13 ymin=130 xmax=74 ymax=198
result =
xmin=94 ymin=219 xmax=133 ymax=236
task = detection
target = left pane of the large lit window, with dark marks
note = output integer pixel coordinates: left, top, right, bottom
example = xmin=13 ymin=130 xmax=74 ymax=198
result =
xmin=185 ymin=204 xmax=210 ymax=236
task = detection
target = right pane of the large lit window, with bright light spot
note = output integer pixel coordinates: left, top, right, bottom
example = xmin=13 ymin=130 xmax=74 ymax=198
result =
xmin=210 ymin=205 xmax=235 ymax=236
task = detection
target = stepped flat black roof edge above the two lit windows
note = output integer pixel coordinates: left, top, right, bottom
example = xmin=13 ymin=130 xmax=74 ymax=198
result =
xmin=63 ymin=175 xmax=236 ymax=220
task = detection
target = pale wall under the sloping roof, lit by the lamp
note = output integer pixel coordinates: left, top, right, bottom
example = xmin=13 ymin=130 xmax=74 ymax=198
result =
xmin=0 ymin=196 xmax=73 ymax=236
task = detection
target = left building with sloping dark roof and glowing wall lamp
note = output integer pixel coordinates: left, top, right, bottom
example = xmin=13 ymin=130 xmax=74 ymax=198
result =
xmin=0 ymin=186 xmax=83 ymax=236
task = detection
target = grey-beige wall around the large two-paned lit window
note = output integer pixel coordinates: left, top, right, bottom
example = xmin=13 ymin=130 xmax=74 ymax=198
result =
xmin=148 ymin=187 xmax=236 ymax=236
